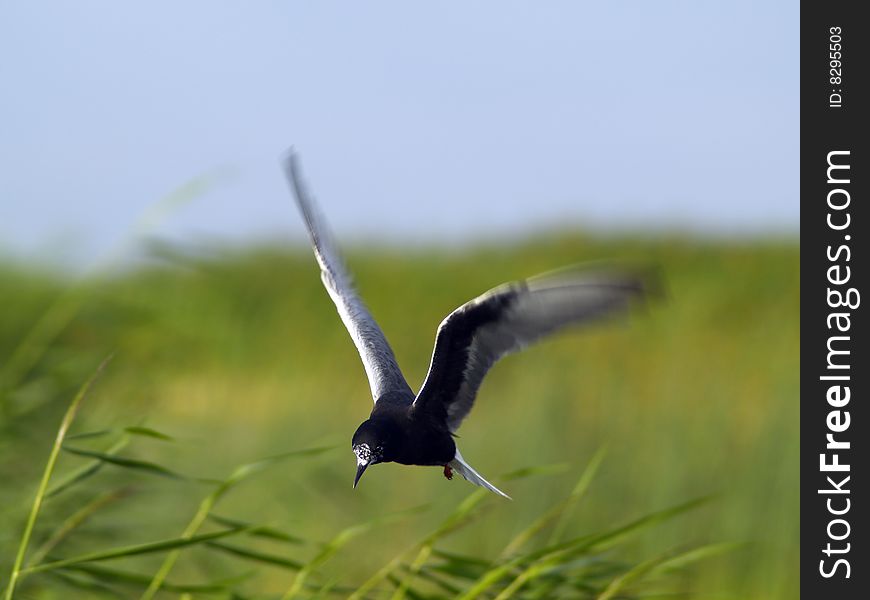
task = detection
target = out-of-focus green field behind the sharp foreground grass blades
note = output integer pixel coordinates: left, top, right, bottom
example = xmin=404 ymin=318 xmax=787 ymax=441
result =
xmin=0 ymin=232 xmax=800 ymax=598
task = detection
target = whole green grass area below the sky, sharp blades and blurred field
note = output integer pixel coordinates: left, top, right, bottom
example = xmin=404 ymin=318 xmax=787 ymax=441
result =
xmin=0 ymin=235 xmax=800 ymax=598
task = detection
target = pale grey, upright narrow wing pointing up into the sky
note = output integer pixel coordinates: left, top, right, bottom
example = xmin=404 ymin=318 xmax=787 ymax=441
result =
xmin=285 ymin=151 xmax=413 ymax=402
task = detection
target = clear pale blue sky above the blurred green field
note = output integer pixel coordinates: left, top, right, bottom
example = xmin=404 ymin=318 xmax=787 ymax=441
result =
xmin=0 ymin=0 xmax=799 ymax=263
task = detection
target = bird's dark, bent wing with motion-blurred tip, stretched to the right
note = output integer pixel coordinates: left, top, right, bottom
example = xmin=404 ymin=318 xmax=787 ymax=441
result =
xmin=414 ymin=269 xmax=647 ymax=432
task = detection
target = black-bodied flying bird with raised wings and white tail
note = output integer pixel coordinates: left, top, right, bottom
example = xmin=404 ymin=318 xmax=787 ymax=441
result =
xmin=284 ymin=149 xmax=650 ymax=499
